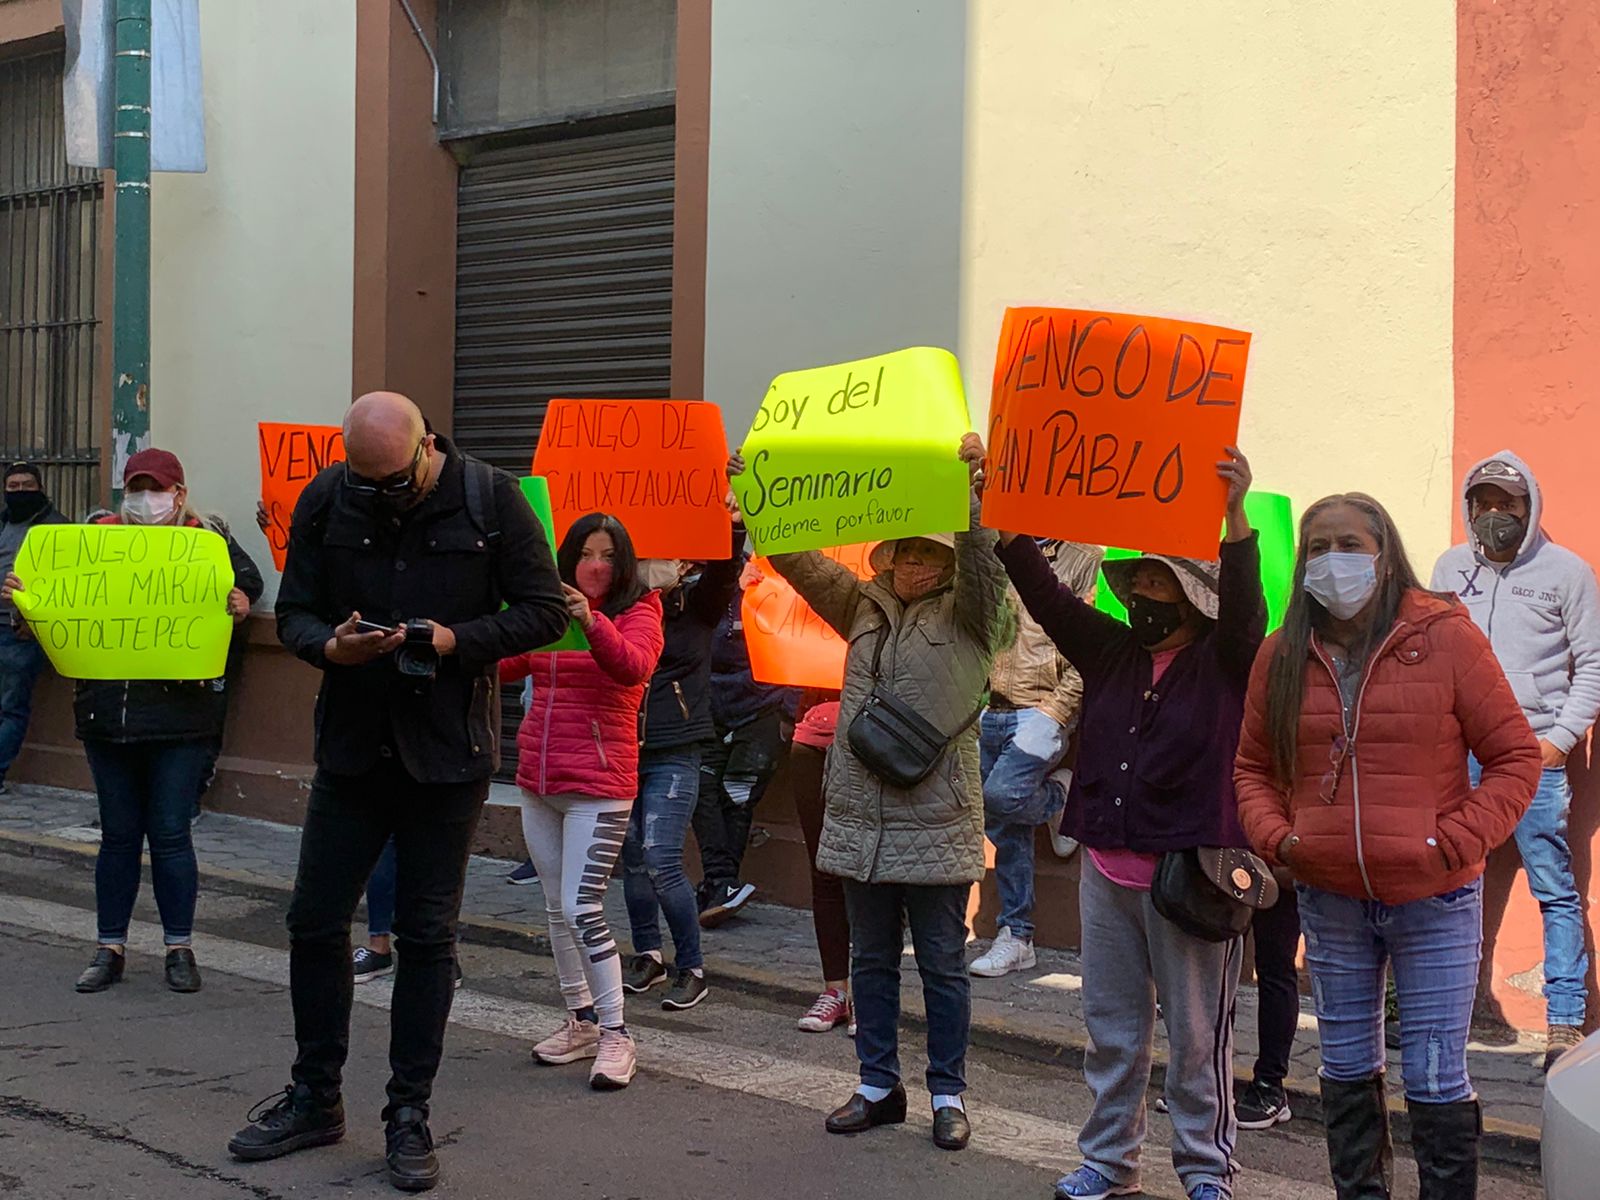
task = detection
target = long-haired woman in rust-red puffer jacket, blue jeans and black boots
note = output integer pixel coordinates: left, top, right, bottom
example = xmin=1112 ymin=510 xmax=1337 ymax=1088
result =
xmin=1235 ymin=494 xmax=1539 ymax=1200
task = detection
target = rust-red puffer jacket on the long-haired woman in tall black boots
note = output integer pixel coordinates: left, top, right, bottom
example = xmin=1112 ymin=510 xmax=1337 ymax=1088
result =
xmin=1234 ymin=592 xmax=1539 ymax=904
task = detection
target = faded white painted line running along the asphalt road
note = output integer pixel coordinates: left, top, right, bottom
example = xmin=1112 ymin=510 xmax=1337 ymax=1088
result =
xmin=0 ymin=896 xmax=1333 ymax=1200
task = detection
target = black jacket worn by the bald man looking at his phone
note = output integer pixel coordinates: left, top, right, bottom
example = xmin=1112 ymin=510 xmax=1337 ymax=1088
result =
xmin=277 ymin=437 xmax=568 ymax=784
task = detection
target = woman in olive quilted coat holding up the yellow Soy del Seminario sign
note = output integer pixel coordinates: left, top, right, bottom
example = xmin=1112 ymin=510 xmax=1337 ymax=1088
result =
xmin=732 ymin=437 xmax=1011 ymax=1150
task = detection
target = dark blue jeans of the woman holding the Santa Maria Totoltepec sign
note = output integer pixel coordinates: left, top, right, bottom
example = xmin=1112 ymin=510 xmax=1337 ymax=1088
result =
xmin=83 ymin=739 xmax=210 ymax=946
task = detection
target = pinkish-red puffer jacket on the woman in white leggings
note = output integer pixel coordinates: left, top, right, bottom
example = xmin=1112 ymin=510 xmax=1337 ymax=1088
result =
xmin=501 ymin=592 xmax=662 ymax=800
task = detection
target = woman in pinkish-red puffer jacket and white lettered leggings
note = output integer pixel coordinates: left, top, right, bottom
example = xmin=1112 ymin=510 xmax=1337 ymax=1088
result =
xmin=501 ymin=512 xmax=662 ymax=1090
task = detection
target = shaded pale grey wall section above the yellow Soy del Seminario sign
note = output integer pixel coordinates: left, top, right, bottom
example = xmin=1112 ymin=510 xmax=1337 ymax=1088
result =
xmin=706 ymin=0 xmax=966 ymax=445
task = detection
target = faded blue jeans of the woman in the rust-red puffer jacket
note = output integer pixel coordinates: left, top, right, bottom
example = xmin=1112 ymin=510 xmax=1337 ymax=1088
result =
xmin=1298 ymin=878 xmax=1483 ymax=1104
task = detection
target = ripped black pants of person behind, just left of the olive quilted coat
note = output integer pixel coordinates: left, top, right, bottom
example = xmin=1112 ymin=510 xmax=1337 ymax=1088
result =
xmin=694 ymin=710 xmax=794 ymax=899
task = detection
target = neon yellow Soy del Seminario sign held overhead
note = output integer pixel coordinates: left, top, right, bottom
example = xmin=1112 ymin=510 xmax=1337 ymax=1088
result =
xmin=733 ymin=347 xmax=971 ymax=554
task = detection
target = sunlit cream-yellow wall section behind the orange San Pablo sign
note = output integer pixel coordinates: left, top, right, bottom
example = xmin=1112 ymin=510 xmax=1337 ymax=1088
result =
xmin=960 ymin=0 xmax=1456 ymax=576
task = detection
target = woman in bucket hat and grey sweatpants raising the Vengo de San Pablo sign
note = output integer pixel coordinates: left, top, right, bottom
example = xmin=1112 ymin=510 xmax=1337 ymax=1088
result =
xmin=998 ymin=448 xmax=1272 ymax=1200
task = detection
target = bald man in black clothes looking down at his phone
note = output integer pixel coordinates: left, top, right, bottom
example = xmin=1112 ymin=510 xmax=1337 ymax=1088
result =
xmin=229 ymin=392 xmax=568 ymax=1190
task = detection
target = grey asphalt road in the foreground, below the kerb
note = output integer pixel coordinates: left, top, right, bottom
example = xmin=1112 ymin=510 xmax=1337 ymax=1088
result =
xmin=0 ymin=854 xmax=1541 ymax=1200
